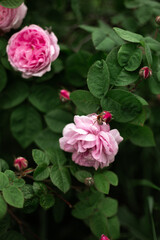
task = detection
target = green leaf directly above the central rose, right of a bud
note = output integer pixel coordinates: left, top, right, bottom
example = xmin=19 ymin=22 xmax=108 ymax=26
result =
xmin=70 ymin=90 xmax=100 ymax=114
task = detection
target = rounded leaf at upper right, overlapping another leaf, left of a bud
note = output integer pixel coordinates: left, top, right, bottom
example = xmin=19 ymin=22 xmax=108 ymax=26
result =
xmin=118 ymin=43 xmax=142 ymax=71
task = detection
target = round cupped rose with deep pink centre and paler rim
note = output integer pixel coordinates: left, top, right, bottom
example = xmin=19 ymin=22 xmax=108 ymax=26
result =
xmin=7 ymin=25 xmax=60 ymax=78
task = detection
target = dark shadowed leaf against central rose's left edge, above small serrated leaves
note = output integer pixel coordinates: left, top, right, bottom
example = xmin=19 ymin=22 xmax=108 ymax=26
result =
xmin=35 ymin=128 xmax=61 ymax=150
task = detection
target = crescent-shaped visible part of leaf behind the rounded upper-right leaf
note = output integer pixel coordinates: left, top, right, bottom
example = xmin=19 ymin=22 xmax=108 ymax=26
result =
xmin=106 ymin=48 xmax=139 ymax=86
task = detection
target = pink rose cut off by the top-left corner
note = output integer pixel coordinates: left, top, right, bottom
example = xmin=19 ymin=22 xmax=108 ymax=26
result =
xmin=0 ymin=3 xmax=27 ymax=32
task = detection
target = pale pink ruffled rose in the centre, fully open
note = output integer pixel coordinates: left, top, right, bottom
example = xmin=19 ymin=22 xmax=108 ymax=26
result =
xmin=59 ymin=114 xmax=123 ymax=169
